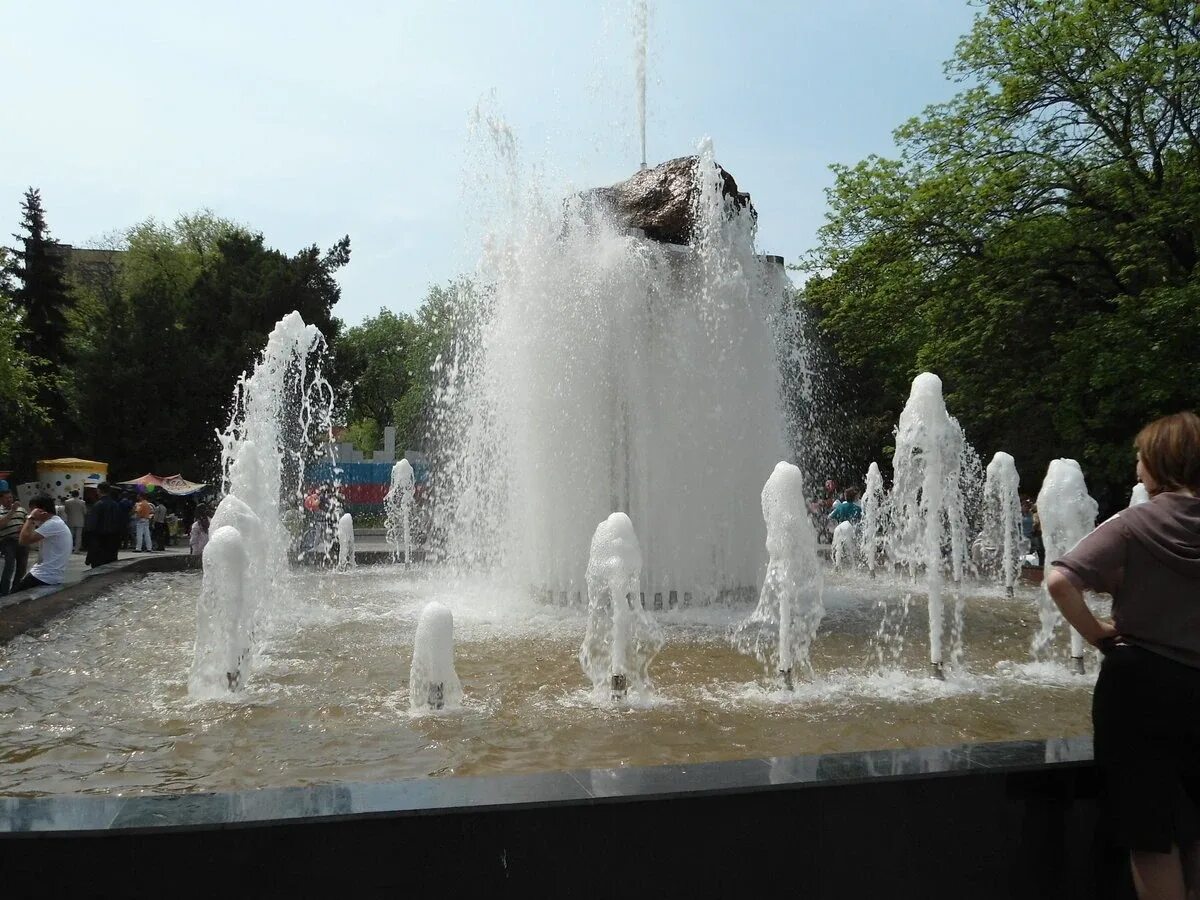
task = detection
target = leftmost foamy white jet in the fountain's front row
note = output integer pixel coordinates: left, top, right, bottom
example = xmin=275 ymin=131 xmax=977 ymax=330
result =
xmin=187 ymin=528 xmax=257 ymax=700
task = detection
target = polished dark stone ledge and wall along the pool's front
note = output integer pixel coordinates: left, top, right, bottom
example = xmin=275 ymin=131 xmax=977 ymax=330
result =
xmin=0 ymin=738 xmax=1132 ymax=900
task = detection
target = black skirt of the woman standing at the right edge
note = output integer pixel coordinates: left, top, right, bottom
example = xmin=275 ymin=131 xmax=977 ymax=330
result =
xmin=1092 ymin=644 xmax=1200 ymax=853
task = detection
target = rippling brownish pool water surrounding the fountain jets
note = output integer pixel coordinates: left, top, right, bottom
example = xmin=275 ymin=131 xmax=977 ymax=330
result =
xmin=0 ymin=568 xmax=1096 ymax=794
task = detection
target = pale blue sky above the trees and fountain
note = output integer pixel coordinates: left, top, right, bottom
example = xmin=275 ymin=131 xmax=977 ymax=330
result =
xmin=0 ymin=0 xmax=974 ymax=323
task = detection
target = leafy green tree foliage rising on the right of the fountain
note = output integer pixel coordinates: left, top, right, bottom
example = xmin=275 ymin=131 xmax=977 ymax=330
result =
xmin=803 ymin=0 xmax=1200 ymax=504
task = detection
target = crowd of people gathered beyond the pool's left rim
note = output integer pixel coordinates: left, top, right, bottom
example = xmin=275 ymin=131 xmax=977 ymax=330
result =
xmin=0 ymin=480 xmax=211 ymax=596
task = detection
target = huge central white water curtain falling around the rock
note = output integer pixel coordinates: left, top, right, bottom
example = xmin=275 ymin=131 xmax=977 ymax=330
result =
xmin=432 ymin=137 xmax=792 ymax=602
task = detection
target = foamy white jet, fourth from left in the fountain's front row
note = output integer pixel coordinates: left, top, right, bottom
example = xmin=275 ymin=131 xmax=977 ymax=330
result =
xmin=733 ymin=462 xmax=824 ymax=690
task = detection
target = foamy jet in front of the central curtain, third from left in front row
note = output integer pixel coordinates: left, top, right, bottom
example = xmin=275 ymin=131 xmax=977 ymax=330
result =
xmin=580 ymin=512 xmax=662 ymax=700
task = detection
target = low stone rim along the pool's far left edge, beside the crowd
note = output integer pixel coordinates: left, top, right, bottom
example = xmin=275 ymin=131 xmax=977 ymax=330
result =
xmin=0 ymin=553 xmax=200 ymax=644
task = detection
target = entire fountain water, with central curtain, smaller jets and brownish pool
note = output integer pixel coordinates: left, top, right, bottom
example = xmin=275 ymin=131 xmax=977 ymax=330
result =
xmin=0 ymin=61 xmax=1094 ymax=793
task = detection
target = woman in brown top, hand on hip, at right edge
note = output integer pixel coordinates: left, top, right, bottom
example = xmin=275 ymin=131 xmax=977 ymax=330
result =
xmin=1046 ymin=413 xmax=1200 ymax=900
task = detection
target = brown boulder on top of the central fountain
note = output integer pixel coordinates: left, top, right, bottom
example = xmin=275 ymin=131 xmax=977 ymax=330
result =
xmin=582 ymin=156 xmax=756 ymax=244
